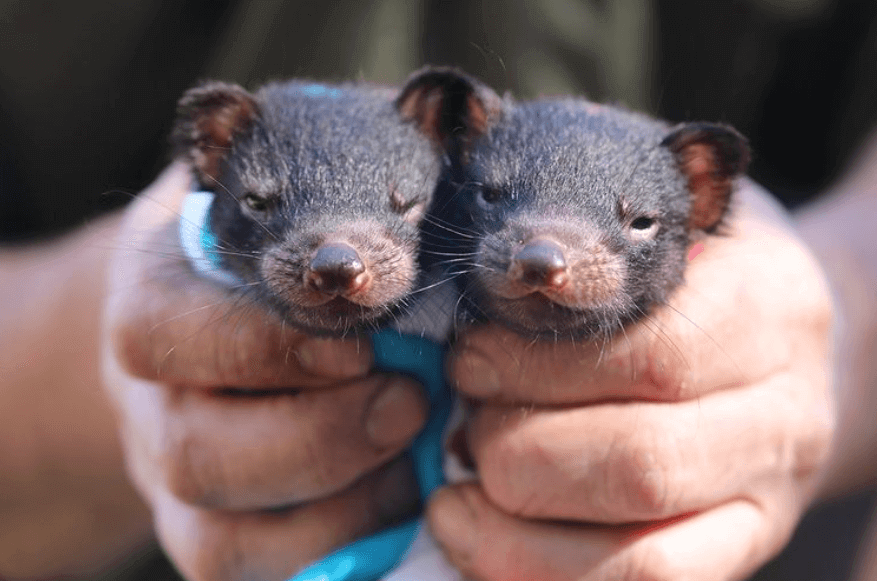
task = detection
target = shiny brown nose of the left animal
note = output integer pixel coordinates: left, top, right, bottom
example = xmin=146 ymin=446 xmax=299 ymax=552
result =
xmin=306 ymin=242 xmax=368 ymax=295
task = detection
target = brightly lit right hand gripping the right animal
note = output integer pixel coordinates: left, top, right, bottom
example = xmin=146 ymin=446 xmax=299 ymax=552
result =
xmin=428 ymin=179 xmax=834 ymax=581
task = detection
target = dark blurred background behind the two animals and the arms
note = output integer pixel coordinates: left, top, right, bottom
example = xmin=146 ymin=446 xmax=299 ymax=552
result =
xmin=0 ymin=0 xmax=877 ymax=581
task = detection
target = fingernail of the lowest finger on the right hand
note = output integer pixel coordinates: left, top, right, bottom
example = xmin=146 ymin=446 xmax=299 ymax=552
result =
xmin=429 ymin=488 xmax=478 ymax=563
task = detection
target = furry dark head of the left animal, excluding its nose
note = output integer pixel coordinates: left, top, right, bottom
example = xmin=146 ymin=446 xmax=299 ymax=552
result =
xmin=174 ymin=81 xmax=441 ymax=334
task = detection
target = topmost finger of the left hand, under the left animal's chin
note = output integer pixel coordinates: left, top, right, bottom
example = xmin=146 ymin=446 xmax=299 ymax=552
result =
xmin=107 ymin=268 xmax=372 ymax=389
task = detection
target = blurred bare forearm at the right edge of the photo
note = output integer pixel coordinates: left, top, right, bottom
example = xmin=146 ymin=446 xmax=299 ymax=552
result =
xmin=795 ymin=130 xmax=877 ymax=498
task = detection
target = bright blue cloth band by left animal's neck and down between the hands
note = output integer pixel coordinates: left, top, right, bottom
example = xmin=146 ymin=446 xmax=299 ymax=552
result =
xmin=179 ymin=192 xmax=453 ymax=581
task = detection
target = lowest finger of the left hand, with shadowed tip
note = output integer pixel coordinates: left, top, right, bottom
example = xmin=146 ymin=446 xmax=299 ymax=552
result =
xmin=153 ymin=462 xmax=418 ymax=581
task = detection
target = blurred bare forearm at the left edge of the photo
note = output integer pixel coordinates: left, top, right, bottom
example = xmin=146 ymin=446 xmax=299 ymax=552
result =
xmin=0 ymin=210 xmax=152 ymax=581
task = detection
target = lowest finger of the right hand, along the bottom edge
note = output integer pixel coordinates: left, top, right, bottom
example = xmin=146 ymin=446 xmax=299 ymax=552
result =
xmin=428 ymin=484 xmax=791 ymax=581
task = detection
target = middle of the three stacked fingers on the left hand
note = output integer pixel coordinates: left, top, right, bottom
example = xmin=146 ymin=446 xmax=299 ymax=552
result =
xmin=107 ymin=346 xmax=427 ymax=509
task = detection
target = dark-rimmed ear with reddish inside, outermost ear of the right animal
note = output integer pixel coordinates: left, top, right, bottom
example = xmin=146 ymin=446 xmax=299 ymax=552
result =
xmin=661 ymin=123 xmax=750 ymax=232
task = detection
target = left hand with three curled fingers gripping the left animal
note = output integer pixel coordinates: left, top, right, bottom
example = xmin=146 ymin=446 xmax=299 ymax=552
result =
xmin=103 ymin=165 xmax=426 ymax=581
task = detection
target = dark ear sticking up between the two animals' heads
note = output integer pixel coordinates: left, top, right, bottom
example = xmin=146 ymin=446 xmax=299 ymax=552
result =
xmin=396 ymin=67 xmax=502 ymax=154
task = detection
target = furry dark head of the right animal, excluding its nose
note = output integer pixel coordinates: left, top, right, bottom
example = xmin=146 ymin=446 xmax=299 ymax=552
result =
xmin=408 ymin=70 xmax=748 ymax=338
